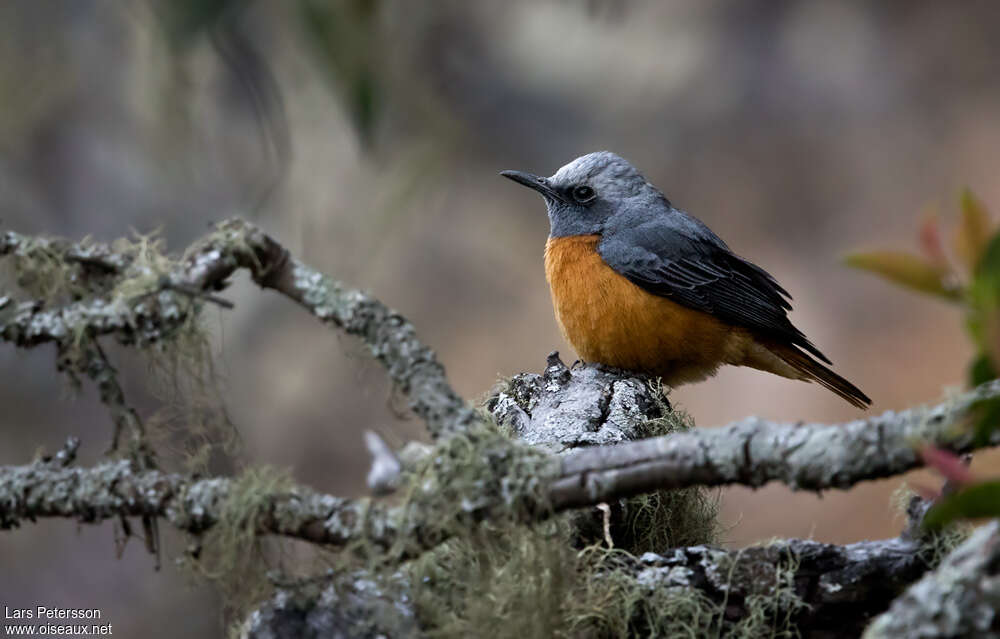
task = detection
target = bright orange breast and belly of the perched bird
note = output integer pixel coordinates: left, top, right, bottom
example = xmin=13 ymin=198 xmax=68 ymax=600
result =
xmin=545 ymin=235 xmax=749 ymax=385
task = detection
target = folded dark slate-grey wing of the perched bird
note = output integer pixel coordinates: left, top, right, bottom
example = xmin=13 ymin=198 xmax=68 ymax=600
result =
xmin=598 ymin=215 xmax=830 ymax=364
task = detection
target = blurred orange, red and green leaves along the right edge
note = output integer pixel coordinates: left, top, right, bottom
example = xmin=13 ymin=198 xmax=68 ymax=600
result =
xmin=845 ymin=189 xmax=1000 ymax=529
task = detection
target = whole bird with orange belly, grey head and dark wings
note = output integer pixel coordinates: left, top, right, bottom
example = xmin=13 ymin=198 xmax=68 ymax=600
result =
xmin=500 ymin=151 xmax=871 ymax=409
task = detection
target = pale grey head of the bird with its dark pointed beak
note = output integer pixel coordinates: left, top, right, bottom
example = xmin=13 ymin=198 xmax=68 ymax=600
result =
xmin=500 ymin=151 xmax=672 ymax=237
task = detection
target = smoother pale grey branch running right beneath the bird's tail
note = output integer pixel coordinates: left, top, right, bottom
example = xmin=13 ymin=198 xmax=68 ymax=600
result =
xmin=549 ymin=381 xmax=1000 ymax=509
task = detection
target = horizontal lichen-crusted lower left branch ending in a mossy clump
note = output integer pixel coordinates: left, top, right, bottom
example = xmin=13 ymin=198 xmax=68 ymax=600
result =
xmin=0 ymin=433 xmax=546 ymax=558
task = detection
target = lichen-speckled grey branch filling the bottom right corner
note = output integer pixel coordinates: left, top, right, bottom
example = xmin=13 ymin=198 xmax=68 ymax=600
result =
xmin=864 ymin=521 xmax=1000 ymax=639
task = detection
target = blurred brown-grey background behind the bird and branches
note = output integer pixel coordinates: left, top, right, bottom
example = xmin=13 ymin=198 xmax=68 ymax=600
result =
xmin=0 ymin=0 xmax=1000 ymax=637
